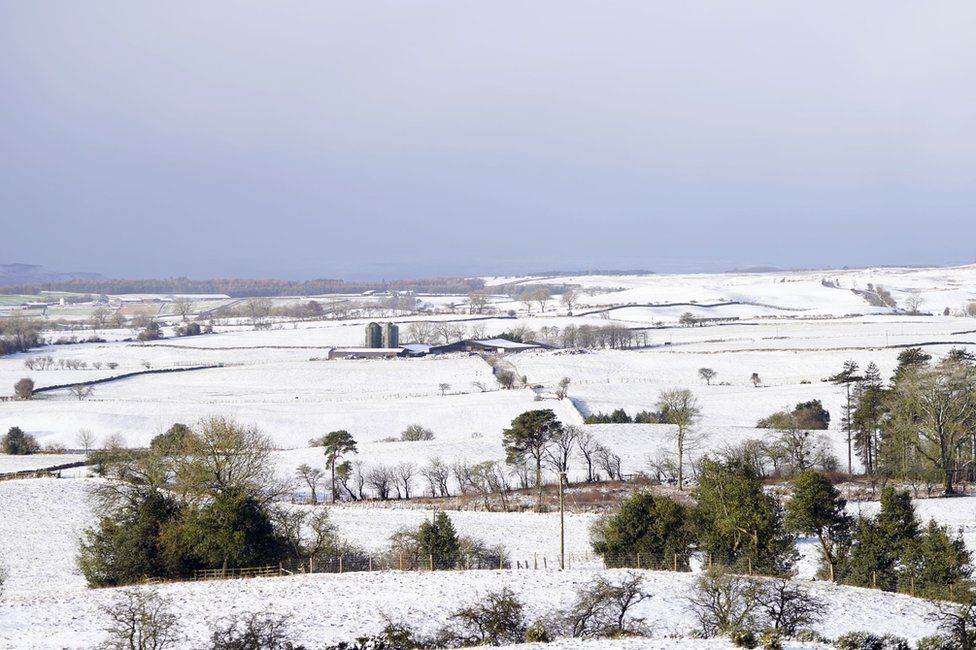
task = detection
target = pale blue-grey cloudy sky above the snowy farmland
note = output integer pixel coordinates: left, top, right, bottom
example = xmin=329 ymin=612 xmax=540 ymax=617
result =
xmin=0 ymin=0 xmax=976 ymax=279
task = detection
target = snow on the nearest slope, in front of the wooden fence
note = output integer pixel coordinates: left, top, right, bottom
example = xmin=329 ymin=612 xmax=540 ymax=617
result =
xmin=0 ymin=570 xmax=934 ymax=648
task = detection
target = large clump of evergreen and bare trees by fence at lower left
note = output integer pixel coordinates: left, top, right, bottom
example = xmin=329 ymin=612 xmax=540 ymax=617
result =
xmin=78 ymin=417 xmax=358 ymax=586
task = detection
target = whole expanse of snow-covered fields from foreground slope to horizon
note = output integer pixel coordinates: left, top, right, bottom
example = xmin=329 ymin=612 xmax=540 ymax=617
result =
xmin=0 ymin=266 xmax=976 ymax=650
